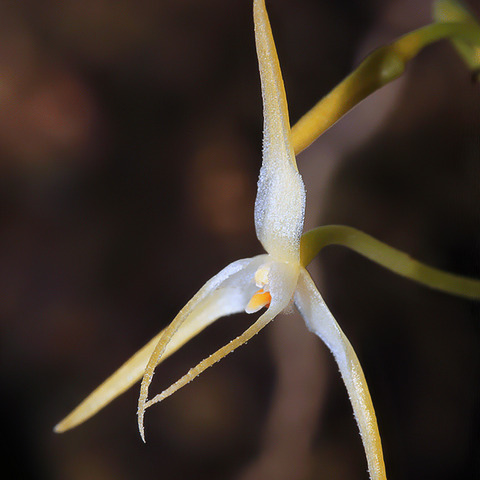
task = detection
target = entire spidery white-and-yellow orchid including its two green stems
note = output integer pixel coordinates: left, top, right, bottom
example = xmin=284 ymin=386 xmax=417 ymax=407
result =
xmin=55 ymin=0 xmax=480 ymax=479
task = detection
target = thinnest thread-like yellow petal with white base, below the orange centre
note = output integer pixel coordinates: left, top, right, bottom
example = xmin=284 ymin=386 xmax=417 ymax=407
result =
xmin=138 ymin=262 xmax=299 ymax=441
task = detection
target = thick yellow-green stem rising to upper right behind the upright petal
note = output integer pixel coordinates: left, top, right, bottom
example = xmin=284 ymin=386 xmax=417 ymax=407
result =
xmin=291 ymin=22 xmax=480 ymax=154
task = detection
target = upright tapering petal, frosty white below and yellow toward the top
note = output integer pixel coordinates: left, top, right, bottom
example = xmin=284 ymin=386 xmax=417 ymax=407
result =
xmin=254 ymin=0 xmax=305 ymax=262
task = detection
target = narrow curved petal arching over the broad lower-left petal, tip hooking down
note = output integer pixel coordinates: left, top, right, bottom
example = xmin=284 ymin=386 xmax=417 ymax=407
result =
xmin=137 ymin=255 xmax=268 ymax=441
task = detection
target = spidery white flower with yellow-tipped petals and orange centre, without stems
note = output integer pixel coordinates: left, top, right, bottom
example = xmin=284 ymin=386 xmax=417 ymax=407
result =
xmin=55 ymin=0 xmax=385 ymax=479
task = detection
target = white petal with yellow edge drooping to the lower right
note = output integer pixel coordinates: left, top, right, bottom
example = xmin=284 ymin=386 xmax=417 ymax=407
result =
xmin=295 ymin=268 xmax=386 ymax=480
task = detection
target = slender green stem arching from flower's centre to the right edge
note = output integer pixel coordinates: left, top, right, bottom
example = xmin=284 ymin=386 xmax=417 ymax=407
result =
xmin=300 ymin=225 xmax=480 ymax=300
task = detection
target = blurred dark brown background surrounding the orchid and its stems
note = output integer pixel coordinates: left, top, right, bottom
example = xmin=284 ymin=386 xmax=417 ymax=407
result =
xmin=0 ymin=0 xmax=480 ymax=480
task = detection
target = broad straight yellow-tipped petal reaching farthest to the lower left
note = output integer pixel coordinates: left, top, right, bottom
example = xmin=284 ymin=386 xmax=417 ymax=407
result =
xmin=55 ymin=255 xmax=266 ymax=433
